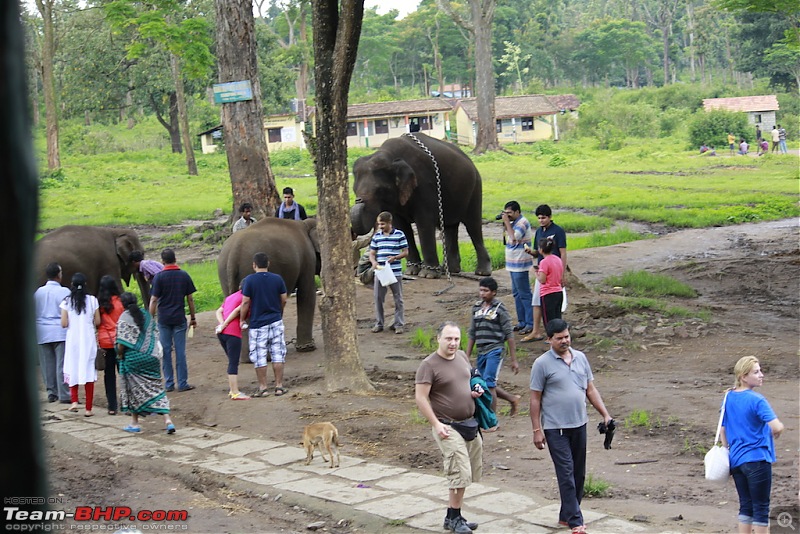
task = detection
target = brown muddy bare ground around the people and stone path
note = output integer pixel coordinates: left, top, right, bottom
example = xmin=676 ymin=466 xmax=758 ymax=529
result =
xmin=47 ymin=220 xmax=800 ymax=533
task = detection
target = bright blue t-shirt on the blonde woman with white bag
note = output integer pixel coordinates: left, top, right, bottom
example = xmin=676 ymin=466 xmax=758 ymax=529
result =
xmin=722 ymin=390 xmax=776 ymax=467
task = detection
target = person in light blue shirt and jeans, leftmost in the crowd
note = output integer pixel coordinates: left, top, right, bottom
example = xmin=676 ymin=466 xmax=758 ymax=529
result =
xmin=33 ymin=262 xmax=71 ymax=404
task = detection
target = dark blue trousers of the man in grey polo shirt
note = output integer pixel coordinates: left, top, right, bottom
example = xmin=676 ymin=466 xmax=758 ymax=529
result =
xmin=544 ymin=425 xmax=586 ymax=528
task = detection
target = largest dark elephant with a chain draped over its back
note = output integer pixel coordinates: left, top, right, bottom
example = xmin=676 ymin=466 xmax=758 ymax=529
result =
xmin=350 ymin=133 xmax=492 ymax=278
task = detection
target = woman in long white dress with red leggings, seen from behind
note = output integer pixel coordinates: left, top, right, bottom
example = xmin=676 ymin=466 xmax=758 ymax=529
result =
xmin=60 ymin=273 xmax=100 ymax=417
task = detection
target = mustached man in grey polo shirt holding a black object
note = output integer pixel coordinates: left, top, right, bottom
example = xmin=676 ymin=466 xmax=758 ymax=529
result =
xmin=530 ymin=319 xmax=612 ymax=533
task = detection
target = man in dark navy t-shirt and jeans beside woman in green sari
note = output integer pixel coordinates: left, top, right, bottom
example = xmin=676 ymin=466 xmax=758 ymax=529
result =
xmin=150 ymin=248 xmax=197 ymax=392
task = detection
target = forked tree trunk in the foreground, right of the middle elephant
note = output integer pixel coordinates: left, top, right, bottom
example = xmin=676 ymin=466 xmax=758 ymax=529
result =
xmin=311 ymin=0 xmax=374 ymax=393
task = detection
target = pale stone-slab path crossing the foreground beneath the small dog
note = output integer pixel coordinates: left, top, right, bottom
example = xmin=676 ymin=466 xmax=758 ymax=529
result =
xmin=42 ymin=403 xmax=672 ymax=534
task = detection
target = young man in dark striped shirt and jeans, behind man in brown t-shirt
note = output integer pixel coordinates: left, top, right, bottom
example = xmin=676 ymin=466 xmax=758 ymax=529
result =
xmin=467 ymin=276 xmax=520 ymax=420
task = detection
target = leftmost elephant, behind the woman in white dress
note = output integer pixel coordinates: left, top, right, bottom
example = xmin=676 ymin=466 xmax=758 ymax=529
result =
xmin=34 ymin=225 xmax=150 ymax=306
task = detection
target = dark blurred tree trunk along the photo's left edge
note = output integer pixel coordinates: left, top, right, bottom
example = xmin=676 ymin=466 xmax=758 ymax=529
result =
xmin=0 ymin=1 xmax=50 ymax=506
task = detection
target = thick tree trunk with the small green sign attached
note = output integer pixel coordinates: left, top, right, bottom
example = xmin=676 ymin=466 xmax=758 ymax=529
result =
xmin=214 ymin=0 xmax=280 ymax=218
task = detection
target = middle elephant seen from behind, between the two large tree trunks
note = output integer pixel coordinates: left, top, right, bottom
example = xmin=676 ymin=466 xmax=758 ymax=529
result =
xmin=217 ymin=217 xmax=321 ymax=354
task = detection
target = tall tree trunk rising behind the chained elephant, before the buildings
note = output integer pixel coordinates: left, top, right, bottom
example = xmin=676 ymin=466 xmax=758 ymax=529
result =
xmin=470 ymin=0 xmax=500 ymax=154
